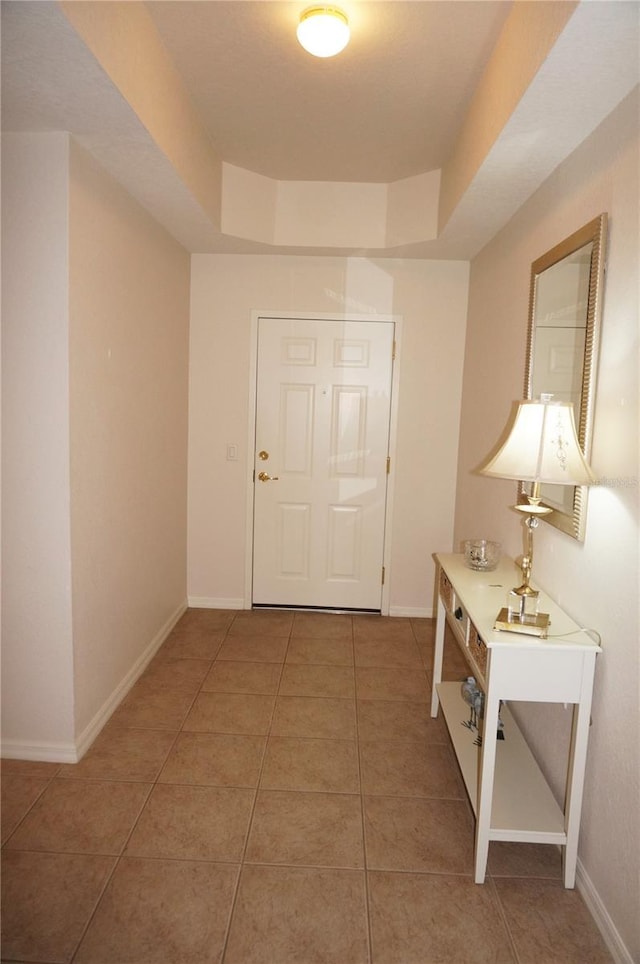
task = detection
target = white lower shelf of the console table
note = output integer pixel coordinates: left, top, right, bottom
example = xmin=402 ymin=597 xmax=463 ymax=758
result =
xmin=437 ymin=683 xmax=567 ymax=844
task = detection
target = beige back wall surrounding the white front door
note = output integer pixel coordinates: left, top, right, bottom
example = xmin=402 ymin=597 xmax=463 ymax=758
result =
xmin=188 ymin=255 xmax=468 ymax=615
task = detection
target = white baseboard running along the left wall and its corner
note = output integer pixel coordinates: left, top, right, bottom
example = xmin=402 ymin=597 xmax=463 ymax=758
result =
xmin=1 ymin=602 xmax=187 ymax=763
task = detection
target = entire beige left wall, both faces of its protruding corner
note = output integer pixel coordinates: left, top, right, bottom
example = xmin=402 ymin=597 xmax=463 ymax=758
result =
xmin=2 ymin=134 xmax=189 ymax=762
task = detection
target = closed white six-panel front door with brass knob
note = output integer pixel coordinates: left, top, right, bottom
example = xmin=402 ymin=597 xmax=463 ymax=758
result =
xmin=253 ymin=318 xmax=394 ymax=610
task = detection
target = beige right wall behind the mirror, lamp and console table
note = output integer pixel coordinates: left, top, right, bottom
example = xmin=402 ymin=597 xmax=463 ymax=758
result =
xmin=455 ymin=91 xmax=640 ymax=960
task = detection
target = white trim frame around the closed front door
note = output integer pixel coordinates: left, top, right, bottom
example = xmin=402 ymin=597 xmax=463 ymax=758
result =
xmin=244 ymin=310 xmax=402 ymax=616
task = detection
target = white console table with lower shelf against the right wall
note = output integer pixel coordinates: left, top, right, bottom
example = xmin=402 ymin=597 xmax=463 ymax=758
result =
xmin=431 ymin=554 xmax=601 ymax=887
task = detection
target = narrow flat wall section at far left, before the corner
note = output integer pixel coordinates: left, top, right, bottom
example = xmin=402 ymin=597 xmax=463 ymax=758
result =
xmin=2 ymin=134 xmax=74 ymax=759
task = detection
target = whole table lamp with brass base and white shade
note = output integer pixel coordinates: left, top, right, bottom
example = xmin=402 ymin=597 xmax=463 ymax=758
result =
xmin=477 ymin=395 xmax=595 ymax=637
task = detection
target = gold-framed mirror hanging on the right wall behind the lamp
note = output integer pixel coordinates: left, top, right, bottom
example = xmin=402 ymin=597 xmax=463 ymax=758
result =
xmin=518 ymin=214 xmax=607 ymax=542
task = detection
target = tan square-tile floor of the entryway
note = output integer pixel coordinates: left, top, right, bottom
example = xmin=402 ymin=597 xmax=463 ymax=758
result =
xmin=2 ymin=610 xmax=611 ymax=964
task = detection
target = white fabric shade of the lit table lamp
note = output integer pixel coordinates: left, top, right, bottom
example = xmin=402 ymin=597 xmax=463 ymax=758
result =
xmin=478 ymin=398 xmax=595 ymax=485
